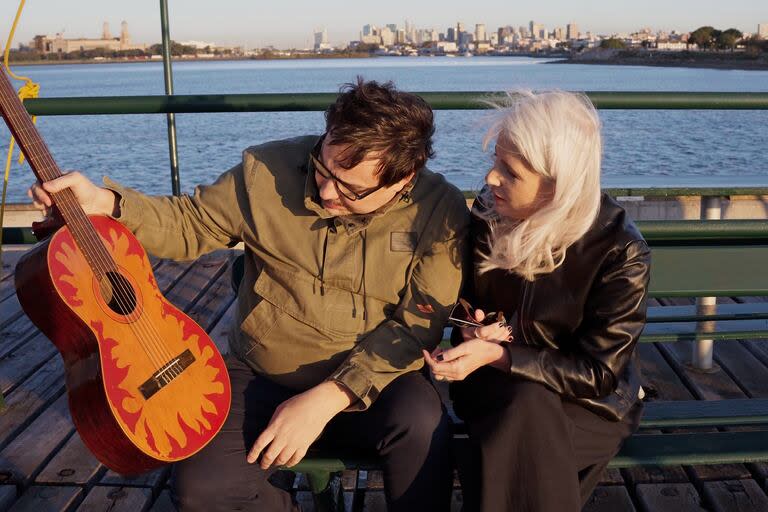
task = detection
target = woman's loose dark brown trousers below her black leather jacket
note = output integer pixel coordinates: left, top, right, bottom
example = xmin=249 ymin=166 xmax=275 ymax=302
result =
xmin=451 ymin=368 xmax=642 ymax=512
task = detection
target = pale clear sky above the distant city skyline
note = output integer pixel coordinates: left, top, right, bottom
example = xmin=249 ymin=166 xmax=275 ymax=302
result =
xmin=0 ymin=0 xmax=768 ymax=48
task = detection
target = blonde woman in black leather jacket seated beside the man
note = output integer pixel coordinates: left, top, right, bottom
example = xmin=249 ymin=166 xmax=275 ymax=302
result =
xmin=424 ymin=92 xmax=650 ymax=512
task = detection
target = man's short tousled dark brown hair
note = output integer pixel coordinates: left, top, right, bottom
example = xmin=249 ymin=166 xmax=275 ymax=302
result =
xmin=325 ymin=76 xmax=435 ymax=186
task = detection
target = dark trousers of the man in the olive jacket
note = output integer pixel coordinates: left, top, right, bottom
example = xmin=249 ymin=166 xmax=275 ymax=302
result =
xmin=172 ymin=357 xmax=453 ymax=511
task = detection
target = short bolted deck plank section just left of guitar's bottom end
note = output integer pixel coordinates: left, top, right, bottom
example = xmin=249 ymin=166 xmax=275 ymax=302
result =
xmin=35 ymin=432 xmax=106 ymax=490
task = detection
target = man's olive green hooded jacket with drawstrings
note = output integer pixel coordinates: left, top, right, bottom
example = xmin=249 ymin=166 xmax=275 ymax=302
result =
xmin=105 ymin=136 xmax=470 ymax=409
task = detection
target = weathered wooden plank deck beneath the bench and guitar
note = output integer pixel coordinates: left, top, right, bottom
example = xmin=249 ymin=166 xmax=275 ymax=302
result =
xmin=0 ymin=246 xmax=768 ymax=512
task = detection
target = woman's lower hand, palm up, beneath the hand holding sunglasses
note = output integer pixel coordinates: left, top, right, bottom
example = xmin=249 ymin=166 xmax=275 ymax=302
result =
xmin=422 ymin=338 xmax=510 ymax=381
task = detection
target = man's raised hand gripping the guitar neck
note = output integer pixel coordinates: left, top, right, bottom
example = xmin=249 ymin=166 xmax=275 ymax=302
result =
xmin=27 ymin=171 xmax=120 ymax=216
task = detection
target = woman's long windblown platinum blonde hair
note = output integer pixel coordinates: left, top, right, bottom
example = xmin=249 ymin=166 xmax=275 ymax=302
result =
xmin=478 ymin=91 xmax=602 ymax=281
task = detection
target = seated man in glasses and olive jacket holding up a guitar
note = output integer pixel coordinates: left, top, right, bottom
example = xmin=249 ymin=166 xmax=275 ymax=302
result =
xmin=30 ymin=79 xmax=469 ymax=511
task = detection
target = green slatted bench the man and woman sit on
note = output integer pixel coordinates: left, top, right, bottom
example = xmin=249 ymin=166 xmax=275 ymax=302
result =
xmin=292 ymin=221 xmax=768 ymax=510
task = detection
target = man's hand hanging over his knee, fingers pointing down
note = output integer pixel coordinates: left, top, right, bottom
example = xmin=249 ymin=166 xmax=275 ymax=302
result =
xmin=247 ymin=382 xmax=354 ymax=470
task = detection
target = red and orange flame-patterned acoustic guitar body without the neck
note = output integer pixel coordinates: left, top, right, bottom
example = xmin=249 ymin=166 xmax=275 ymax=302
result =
xmin=16 ymin=216 xmax=231 ymax=475
